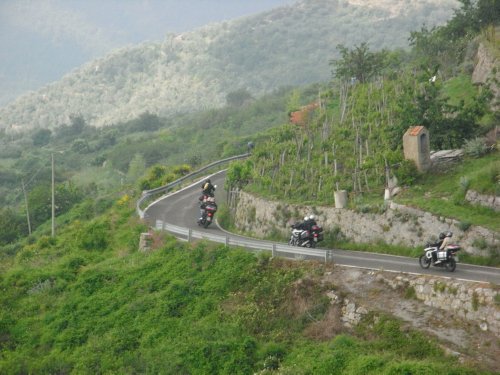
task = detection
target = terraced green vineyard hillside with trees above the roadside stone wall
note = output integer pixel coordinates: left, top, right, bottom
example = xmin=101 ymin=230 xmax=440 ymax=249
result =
xmin=228 ymin=1 xmax=500 ymax=235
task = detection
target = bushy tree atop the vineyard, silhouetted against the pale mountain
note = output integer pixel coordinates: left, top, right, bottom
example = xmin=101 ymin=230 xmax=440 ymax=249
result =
xmin=330 ymin=42 xmax=386 ymax=83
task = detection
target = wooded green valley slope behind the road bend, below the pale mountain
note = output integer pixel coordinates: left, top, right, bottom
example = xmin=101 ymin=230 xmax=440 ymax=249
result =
xmin=0 ymin=86 xmax=294 ymax=244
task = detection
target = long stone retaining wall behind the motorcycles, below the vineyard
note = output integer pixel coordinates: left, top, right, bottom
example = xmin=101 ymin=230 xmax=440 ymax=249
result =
xmin=235 ymin=192 xmax=500 ymax=255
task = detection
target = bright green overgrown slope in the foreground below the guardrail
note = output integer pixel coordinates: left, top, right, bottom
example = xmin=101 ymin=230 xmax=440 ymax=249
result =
xmin=0 ymin=196 xmax=487 ymax=374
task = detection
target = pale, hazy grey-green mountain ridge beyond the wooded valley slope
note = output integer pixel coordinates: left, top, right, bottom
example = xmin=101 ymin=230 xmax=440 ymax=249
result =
xmin=0 ymin=0 xmax=458 ymax=131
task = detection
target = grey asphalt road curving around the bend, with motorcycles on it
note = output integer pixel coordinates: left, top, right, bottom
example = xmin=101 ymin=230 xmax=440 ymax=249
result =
xmin=144 ymin=172 xmax=500 ymax=285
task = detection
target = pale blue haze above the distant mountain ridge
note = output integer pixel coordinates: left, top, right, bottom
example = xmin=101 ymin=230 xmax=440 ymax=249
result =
xmin=0 ymin=0 xmax=296 ymax=105
